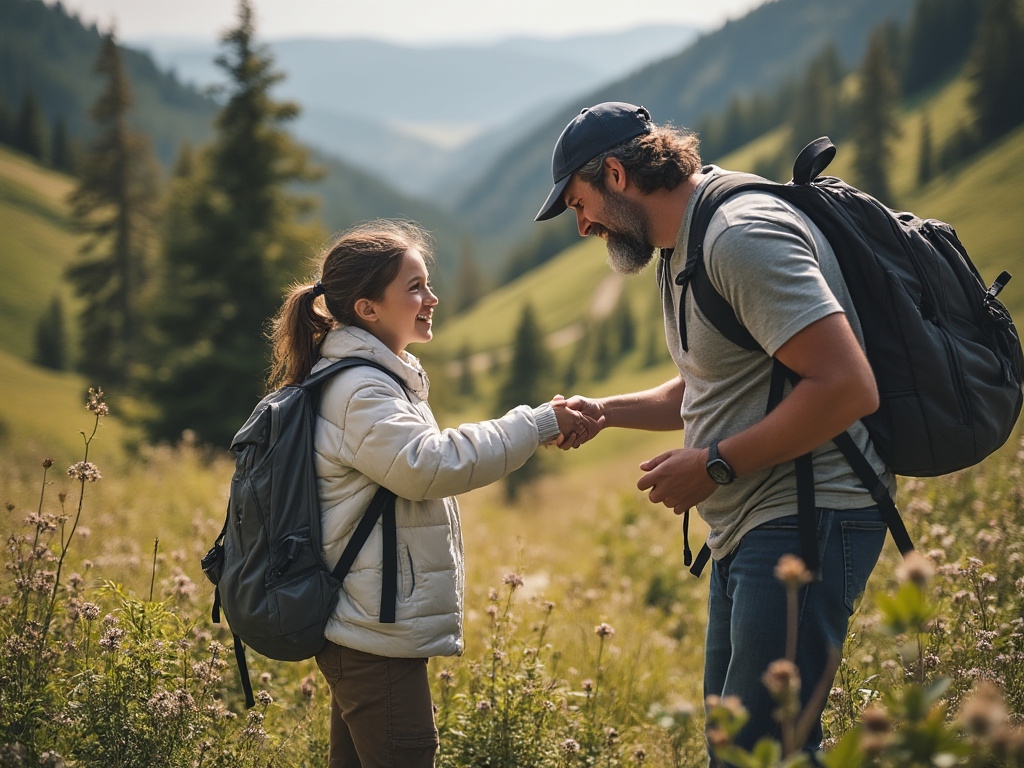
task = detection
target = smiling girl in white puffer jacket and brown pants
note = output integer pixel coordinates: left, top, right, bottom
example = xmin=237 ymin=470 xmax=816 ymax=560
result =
xmin=270 ymin=221 xmax=594 ymax=768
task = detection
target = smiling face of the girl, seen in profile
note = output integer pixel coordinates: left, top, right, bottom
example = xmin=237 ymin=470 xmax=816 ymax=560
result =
xmin=355 ymin=248 xmax=437 ymax=354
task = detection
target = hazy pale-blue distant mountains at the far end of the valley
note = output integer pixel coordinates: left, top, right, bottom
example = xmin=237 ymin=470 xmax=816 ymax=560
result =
xmin=133 ymin=26 xmax=698 ymax=199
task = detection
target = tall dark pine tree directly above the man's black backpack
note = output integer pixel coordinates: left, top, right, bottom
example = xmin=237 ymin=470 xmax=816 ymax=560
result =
xmin=853 ymin=26 xmax=899 ymax=205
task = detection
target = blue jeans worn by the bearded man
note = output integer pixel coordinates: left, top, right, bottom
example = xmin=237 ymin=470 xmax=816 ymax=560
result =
xmin=705 ymin=507 xmax=886 ymax=765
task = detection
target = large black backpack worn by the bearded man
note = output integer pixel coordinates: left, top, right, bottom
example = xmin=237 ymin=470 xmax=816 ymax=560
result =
xmin=662 ymin=137 xmax=1024 ymax=573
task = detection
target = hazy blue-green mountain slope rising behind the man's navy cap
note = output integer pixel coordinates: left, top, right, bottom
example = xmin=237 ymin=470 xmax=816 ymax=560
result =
xmin=456 ymin=0 xmax=913 ymax=246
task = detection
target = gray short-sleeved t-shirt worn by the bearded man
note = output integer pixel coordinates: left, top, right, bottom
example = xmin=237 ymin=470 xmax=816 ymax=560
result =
xmin=662 ymin=166 xmax=895 ymax=559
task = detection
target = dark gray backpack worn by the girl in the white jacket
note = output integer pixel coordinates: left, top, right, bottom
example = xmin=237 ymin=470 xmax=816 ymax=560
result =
xmin=203 ymin=357 xmax=404 ymax=707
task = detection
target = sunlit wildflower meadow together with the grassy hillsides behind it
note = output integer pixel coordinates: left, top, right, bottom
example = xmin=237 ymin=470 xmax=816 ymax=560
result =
xmin=0 ymin=75 xmax=1024 ymax=768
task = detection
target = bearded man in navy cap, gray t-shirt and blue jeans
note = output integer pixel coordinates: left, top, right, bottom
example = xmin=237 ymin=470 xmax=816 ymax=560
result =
xmin=537 ymin=102 xmax=893 ymax=765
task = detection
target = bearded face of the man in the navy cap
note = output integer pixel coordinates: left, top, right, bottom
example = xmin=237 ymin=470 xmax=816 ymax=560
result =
xmin=565 ymin=178 xmax=654 ymax=274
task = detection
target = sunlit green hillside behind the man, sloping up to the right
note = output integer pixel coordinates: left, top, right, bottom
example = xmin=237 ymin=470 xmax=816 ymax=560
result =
xmin=430 ymin=80 xmax=1024 ymax=411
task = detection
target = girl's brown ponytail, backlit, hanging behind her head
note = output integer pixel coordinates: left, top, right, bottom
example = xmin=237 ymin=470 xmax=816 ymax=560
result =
xmin=267 ymin=283 xmax=335 ymax=390
